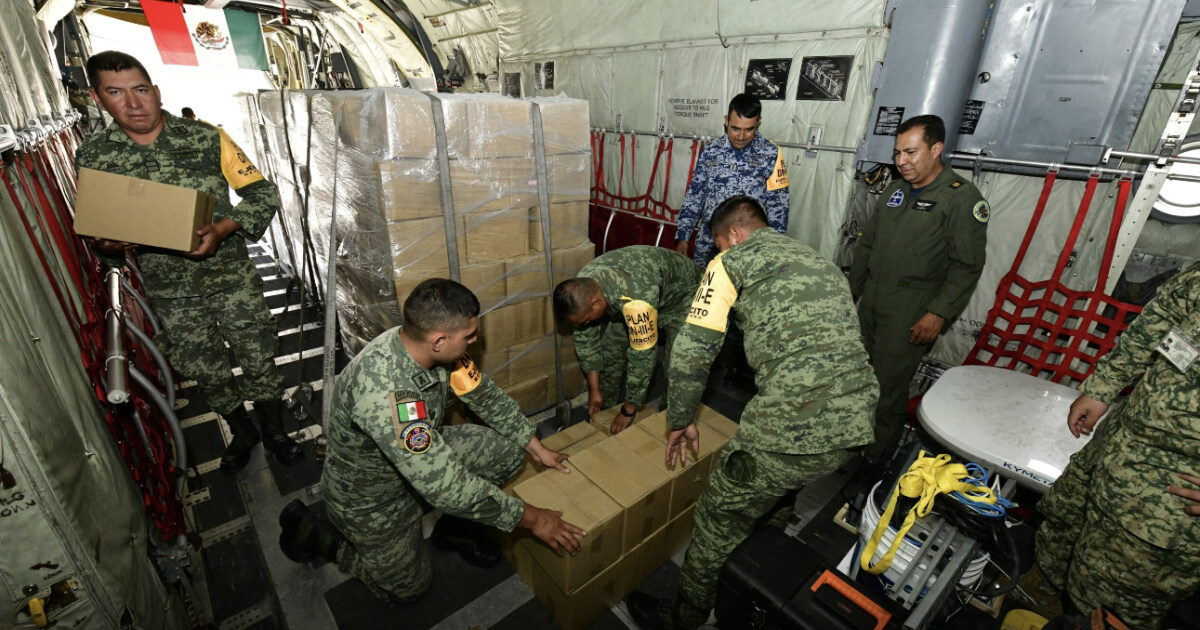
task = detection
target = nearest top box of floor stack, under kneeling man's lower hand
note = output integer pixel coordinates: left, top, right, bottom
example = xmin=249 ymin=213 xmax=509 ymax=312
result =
xmin=514 ymin=465 xmax=625 ymax=593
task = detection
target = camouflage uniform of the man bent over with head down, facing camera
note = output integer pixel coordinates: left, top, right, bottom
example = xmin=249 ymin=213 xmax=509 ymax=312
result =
xmin=575 ymin=245 xmax=700 ymax=404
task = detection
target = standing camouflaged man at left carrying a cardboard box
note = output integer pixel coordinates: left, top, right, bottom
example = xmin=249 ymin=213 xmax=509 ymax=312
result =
xmin=76 ymin=50 xmax=304 ymax=472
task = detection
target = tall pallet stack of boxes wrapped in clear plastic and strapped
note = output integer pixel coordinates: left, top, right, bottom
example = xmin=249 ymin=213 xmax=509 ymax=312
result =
xmin=258 ymin=88 xmax=594 ymax=410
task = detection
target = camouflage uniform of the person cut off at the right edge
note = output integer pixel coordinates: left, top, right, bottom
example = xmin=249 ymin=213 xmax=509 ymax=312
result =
xmin=1037 ymin=263 xmax=1200 ymax=628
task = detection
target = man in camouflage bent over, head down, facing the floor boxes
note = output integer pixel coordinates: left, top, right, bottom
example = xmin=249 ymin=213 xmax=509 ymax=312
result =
xmin=554 ymin=245 xmax=700 ymax=433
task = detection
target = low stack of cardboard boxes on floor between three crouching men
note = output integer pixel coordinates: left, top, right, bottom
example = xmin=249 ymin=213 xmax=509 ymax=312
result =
xmin=502 ymin=406 xmax=737 ymax=630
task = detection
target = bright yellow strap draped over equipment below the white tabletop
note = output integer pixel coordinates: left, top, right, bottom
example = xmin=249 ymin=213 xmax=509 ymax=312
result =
xmin=858 ymin=450 xmax=996 ymax=575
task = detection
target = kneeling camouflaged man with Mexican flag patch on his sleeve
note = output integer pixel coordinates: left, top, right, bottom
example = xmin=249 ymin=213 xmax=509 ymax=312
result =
xmin=280 ymin=278 xmax=583 ymax=602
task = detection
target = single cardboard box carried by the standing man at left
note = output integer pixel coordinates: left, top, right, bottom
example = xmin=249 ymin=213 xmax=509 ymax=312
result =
xmin=74 ymin=168 xmax=213 ymax=252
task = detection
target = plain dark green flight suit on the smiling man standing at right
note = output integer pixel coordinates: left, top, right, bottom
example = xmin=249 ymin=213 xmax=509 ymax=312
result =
xmin=850 ymin=167 xmax=990 ymax=455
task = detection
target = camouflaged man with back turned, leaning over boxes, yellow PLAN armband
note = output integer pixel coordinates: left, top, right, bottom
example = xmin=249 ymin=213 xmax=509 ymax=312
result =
xmin=629 ymin=197 xmax=878 ymax=629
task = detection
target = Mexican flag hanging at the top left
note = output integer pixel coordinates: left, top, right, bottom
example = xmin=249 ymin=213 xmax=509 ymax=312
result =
xmin=142 ymin=0 xmax=268 ymax=70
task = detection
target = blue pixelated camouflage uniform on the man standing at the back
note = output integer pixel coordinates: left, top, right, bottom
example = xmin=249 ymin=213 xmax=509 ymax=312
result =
xmin=676 ymin=134 xmax=788 ymax=266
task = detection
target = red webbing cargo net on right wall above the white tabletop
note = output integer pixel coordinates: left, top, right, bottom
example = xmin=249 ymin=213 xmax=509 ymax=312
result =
xmin=964 ymin=170 xmax=1141 ymax=386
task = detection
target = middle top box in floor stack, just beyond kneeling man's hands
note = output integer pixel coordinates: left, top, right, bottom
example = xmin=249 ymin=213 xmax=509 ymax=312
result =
xmin=571 ymin=438 xmax=671 ymax=553
